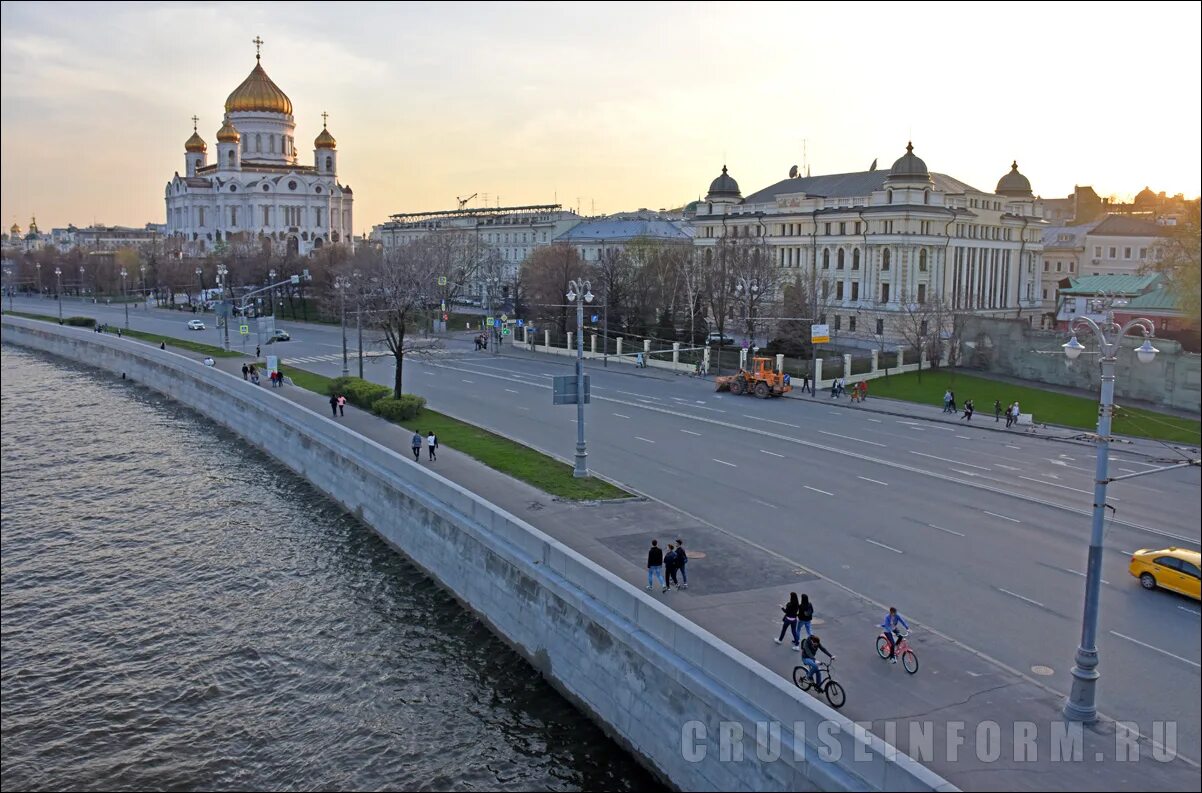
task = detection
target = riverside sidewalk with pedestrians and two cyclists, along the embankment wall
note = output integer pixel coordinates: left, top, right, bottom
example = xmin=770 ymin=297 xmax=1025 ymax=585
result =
xmin=197 ymin=356 xmax=1197 ymax=791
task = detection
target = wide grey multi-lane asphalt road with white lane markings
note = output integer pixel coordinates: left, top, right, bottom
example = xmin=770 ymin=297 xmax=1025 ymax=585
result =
xmin=16 ymin=298 xmax=1202 ymax=761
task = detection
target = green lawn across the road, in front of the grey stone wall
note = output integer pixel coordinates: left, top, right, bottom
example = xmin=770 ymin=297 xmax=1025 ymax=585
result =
xmin=868 ymin=369 xmax=1202 ymax=445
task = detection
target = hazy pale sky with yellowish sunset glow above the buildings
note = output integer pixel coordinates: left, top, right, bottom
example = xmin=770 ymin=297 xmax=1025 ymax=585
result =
xmin=0 ymin=2 xmax=1202 ymax=232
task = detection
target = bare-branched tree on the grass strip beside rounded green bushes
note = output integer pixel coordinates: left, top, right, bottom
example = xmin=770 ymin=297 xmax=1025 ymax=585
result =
xmin=351 ymin=238 xmax=442 ymax=397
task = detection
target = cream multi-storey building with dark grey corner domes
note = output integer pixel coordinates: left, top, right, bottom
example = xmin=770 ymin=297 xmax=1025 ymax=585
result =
xmin=690 ymin=144 xmax=1046 ymax=344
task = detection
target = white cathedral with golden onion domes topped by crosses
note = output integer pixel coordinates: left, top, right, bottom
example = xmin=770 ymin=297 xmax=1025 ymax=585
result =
xmin=165 ymin=37 xmax=355 ymax=256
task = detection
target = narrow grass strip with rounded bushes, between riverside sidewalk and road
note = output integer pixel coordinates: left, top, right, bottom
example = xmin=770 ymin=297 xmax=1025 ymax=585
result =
xmin=272 ymin=366 xmax=631 ymax=501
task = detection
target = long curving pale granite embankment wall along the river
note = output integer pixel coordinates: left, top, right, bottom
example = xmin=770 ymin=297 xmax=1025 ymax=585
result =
xmin=2 ymin=316 xmax=954 ymax=791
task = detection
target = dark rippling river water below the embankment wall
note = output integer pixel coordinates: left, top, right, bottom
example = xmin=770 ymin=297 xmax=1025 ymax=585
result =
xmin=0 ymin=347 xmax=657 ymax=791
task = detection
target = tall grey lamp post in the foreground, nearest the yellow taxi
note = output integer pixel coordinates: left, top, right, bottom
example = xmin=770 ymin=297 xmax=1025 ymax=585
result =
xmin=1061 ymin=300 xmax=1159 ymax=722
